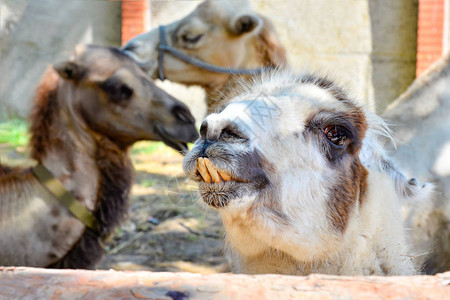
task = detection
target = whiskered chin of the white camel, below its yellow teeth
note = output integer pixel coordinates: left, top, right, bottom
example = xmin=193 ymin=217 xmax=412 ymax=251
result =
xmin=199 ymin=180 xmax=251 ymax=209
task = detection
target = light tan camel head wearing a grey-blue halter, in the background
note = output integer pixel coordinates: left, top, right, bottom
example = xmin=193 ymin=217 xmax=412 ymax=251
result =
xmin=123 ymin=0 xmax=286 ymax=113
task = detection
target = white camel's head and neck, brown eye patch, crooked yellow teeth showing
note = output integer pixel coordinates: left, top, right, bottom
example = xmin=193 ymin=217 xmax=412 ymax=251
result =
xmin=184 ymin=71 xmax=422 ymax=274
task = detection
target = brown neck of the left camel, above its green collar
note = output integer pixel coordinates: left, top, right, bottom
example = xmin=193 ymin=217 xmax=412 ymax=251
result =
xmin=30 ymin=74 xmax=132 ymax=227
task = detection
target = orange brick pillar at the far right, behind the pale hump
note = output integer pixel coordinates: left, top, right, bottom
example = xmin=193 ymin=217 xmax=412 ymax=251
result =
xmin=416 ymin=0 xmax=445 ymax=76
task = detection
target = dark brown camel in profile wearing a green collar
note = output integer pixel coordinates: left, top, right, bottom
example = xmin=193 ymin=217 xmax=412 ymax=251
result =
xmin=0 ymin=46 xmax=197 ymax=268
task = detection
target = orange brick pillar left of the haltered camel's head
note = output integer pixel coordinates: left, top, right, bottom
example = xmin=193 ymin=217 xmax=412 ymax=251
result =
xmin=122 ymin=0 xmax=149 ymax=44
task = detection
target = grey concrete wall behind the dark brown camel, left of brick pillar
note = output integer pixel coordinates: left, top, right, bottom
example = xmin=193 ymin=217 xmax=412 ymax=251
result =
xmin=0 ymin=0 xmax=121 ymax=118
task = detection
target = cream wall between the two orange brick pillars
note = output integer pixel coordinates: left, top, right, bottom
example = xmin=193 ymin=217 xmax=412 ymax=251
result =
xmin=151 ymin=0 xmax=418 ymax=115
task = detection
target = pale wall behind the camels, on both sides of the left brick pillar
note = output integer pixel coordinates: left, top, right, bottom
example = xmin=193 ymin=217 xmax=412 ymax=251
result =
xmin=0 ymin=0 xmax=420 ymax=119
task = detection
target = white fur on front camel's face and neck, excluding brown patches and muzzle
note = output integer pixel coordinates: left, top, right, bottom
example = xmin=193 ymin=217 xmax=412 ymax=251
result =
xmin=200 ymin=70 xmax=426 ymax=275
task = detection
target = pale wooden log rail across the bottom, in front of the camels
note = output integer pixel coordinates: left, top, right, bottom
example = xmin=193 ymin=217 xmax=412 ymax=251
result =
xmin=0 ymin=267 xmax=450 ymax=300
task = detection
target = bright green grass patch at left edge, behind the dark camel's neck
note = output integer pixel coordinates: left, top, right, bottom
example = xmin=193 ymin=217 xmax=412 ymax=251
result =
xmin=0 ymin=118 xmax=29 ymax=147
